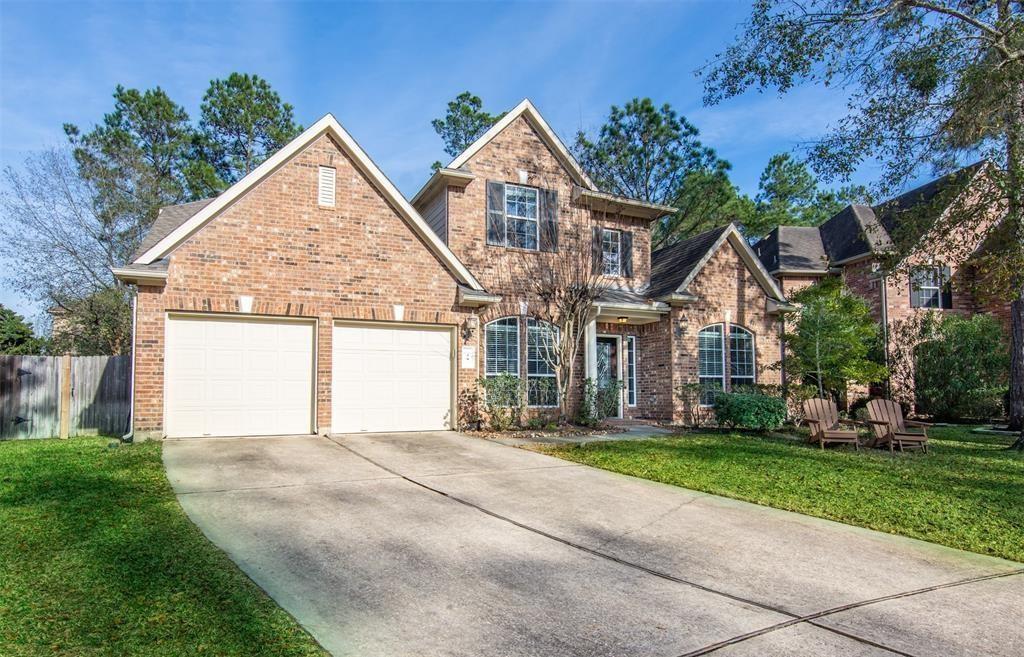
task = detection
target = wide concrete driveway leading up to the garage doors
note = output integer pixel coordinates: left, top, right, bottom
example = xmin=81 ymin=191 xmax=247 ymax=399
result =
xmin=164 ymin=433 xmax=1024 ymax=657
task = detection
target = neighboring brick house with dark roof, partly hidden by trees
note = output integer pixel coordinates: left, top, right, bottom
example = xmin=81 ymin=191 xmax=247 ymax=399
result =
xmin=754 ymin=163 xmax=1009 ymax=399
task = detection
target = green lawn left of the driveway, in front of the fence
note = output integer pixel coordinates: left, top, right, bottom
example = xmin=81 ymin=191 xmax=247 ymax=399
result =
xmin=0 ymin=438 xmax=326 ymax=657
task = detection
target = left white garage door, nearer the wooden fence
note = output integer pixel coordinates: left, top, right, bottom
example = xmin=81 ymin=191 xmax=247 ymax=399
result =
xmin=165 ymin=317 xmax=313 ymax=437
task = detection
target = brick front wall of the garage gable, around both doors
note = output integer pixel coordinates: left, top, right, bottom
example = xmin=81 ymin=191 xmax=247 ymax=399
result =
xmin=134 ymin=136 xmax=476 ymax=435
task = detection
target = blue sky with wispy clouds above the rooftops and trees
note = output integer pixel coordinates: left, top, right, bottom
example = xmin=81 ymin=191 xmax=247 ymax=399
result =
xmin=0 ymin=0 xmax=871 ymax=314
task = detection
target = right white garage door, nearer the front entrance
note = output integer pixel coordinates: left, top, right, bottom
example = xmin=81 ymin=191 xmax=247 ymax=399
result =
xmin=331 ymin=324 xmax=452 ymax=433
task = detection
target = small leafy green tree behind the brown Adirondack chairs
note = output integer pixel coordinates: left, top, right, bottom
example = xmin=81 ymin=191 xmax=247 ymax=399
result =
xmin=782 ymin=277 xmax=888 ymax=397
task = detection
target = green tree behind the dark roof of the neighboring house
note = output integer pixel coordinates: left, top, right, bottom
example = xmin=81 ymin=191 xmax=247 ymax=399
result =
xmin=743 ymin=152 xmax=868 ymax=239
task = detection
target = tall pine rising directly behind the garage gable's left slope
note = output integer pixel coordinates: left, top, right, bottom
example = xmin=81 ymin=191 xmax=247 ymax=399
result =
xmin=199 ymin=73 xmax=302 ymax=184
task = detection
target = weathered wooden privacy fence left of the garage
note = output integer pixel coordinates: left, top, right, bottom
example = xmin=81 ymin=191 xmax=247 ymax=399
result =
xmin=0 ymin=355 xmax=131 ymax=440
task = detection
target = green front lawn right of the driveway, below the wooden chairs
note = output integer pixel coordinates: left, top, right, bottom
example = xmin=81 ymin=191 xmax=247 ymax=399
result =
xmin=538 ymin=427 xmax=1024 ymax=562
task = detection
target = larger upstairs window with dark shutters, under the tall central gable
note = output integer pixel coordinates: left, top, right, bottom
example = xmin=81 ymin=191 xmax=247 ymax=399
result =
xmin=486 ymin=180 xmax=558 ymax=252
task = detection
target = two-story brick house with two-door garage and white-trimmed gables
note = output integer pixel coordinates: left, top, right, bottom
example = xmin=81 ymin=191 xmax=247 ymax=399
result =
xmin=115 ymin=100 xmax=786 ymax=438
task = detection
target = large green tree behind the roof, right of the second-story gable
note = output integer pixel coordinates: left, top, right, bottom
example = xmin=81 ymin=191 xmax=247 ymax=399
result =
xmin=572 ymin=98 xmax=741 ymax=248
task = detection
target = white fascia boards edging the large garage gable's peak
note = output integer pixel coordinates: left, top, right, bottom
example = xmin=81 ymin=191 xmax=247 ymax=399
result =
xmin=135 ymin=114 xmax=483 ymax=290
